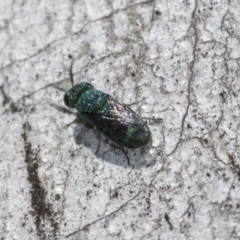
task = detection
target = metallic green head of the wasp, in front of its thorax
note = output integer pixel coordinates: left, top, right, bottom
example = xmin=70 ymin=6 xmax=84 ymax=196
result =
xmin=64 ymin=82 xmax=93 ymax=108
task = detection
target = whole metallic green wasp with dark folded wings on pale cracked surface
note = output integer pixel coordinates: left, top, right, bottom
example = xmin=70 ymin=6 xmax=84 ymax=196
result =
xmin=64 ymin=61 xmax=150 ymax=161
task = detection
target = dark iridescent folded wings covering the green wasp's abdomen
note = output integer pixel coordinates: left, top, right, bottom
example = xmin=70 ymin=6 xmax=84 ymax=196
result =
xmin=81 ymin=96 xmax=150 ymax=148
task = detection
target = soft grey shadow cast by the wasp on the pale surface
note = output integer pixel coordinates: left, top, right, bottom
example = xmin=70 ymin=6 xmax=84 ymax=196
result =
xmin=51 ymin=100 xmax=156 ymax=169
